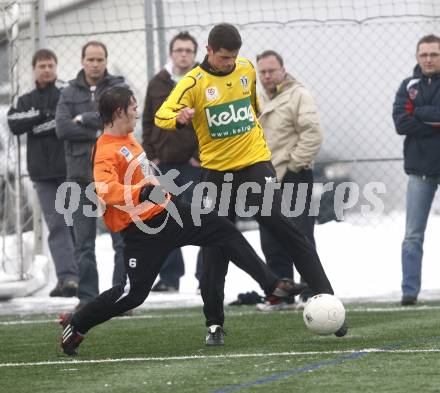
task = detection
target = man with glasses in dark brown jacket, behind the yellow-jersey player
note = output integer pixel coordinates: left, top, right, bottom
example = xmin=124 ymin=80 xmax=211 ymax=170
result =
xmin=142 ymin=31 xmax=201 ymax=292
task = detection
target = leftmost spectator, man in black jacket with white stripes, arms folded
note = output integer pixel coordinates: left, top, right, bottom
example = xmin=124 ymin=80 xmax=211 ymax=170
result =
xmin=8 ymin=49 xmax=78 ymax=297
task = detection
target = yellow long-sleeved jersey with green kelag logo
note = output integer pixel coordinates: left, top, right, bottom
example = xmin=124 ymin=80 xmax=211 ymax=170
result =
xmin=155 ymin=57 xmax=271 ymax=171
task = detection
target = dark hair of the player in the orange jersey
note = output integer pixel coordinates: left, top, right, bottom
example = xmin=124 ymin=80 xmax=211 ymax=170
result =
xmin=98 ymin=86 xmax=135 ymax=125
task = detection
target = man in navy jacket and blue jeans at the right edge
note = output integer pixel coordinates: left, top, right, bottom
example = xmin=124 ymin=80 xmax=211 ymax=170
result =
xmin=393 ymin=35 xmax=440 ymax=306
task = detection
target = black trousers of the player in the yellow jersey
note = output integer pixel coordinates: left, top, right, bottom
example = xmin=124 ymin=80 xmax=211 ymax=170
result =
xmin=200 ymin=161 xmax=333 ymax=326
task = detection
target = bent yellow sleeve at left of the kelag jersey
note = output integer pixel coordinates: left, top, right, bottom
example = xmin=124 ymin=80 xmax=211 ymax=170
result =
xmin=154 ymin=76 xmax=196 ymax=130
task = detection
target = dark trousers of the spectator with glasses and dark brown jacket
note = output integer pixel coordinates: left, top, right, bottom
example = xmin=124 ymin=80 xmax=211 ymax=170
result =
xmin=159 ymin=163 xmax=200 ymax=288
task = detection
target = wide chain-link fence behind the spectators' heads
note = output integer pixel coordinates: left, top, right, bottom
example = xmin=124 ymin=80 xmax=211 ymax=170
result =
xmin=0 ymin=0 xmax=440 ymax=284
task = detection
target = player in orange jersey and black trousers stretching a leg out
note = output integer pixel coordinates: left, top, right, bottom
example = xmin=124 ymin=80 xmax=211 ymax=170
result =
xmin=60 ymin=87 xmax=304 ymax=356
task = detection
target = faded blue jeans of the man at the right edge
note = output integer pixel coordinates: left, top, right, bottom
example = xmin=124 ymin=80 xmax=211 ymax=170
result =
xmin=402 ymin=175 xmax=440 ymax=298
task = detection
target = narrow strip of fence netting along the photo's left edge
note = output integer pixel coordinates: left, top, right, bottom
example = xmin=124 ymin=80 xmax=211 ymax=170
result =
xmin=0 ymin=1 xmax=33 ymax=282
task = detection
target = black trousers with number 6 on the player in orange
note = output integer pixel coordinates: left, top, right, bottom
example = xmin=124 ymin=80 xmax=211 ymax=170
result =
xmin=72 ymin=199 xmax=278 ymax=333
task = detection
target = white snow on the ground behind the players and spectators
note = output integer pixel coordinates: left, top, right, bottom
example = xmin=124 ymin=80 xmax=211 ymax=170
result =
xmin=0 ymin=214 xmax=440 ymax=314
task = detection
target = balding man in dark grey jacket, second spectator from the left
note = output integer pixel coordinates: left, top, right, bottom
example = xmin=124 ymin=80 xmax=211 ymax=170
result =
xmin=56 ymin=41 xmax=125 ymax=309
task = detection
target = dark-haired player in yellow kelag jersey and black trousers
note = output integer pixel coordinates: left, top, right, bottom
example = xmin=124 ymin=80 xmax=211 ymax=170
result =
xmin=155 ymin=23 xmax=347 ymax=343
